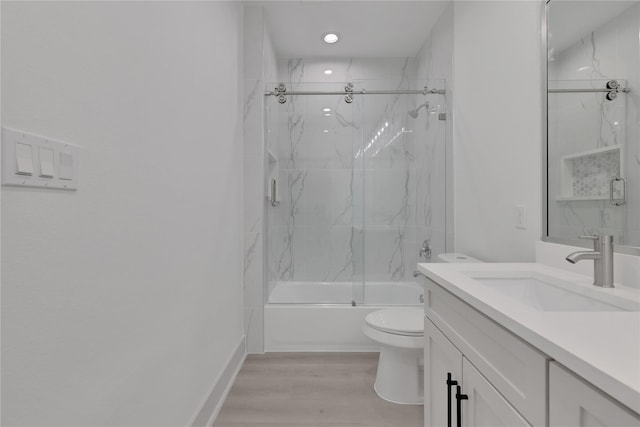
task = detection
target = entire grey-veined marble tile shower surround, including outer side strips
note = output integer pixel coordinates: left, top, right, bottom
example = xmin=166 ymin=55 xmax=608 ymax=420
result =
xmin=243 ymin=6 xmax=453 ymax=353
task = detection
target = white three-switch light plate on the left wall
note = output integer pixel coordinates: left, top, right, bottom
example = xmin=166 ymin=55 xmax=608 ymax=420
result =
xmin=2 ymin=127 xmax=79 ymax=190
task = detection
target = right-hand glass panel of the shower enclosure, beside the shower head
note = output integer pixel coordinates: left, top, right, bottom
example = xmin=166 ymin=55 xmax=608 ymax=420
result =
xmin=355 ymin=80 xmax=446 ymax=305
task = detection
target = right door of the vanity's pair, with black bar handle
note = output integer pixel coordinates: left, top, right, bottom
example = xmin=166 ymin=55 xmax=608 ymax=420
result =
xmin=462 ymin=358 xmax=528 ymax=427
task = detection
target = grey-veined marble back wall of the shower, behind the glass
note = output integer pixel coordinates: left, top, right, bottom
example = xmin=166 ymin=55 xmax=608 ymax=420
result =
xmin=267 ymin=58 xmax=445 ymax=283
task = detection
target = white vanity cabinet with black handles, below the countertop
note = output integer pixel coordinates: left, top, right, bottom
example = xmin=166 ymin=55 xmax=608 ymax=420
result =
xmin=421 ymin=278 xmax=640 ymax=427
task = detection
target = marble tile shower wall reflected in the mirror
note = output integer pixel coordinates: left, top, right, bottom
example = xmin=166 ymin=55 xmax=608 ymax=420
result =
xmin=548 ymin=4 xmax=640 ymax=246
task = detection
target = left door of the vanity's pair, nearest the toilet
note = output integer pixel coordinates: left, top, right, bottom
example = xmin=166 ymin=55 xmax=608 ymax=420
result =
xmin=424 ymin=317 xmax=462 ymax=427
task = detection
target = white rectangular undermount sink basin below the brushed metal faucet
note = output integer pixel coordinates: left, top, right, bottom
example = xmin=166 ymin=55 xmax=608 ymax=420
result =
xmin=467 ymin=271 xmax=640 ymax=312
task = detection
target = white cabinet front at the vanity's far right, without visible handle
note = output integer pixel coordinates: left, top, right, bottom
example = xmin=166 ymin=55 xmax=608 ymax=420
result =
xmin=549 ymin=362 xmax=640 ymax=427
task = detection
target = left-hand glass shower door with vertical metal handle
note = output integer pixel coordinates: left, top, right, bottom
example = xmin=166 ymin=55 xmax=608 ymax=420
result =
xmin=266 ymin=83 xmax=364 ymax=304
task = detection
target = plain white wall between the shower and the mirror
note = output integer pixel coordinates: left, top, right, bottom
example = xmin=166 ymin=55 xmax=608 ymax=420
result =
xmin=453 ymin=0 xmax=542 ymax=261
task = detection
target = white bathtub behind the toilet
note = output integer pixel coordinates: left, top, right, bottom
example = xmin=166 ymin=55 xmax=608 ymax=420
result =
xmin=264 ymin=282 xmax=424 ymax=352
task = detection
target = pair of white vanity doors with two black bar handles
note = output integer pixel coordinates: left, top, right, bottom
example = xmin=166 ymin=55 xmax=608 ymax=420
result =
xmin=424 ymin=319 xmax=530 ymax=427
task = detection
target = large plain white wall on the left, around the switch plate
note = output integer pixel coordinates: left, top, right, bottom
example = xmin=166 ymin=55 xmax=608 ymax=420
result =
xmin=2 ymin=1 xmax=243 ymax=426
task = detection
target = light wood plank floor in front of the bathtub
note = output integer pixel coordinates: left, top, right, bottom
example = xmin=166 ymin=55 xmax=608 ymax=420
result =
xmin=214 ymin=353 xmax=423 ymax=427
